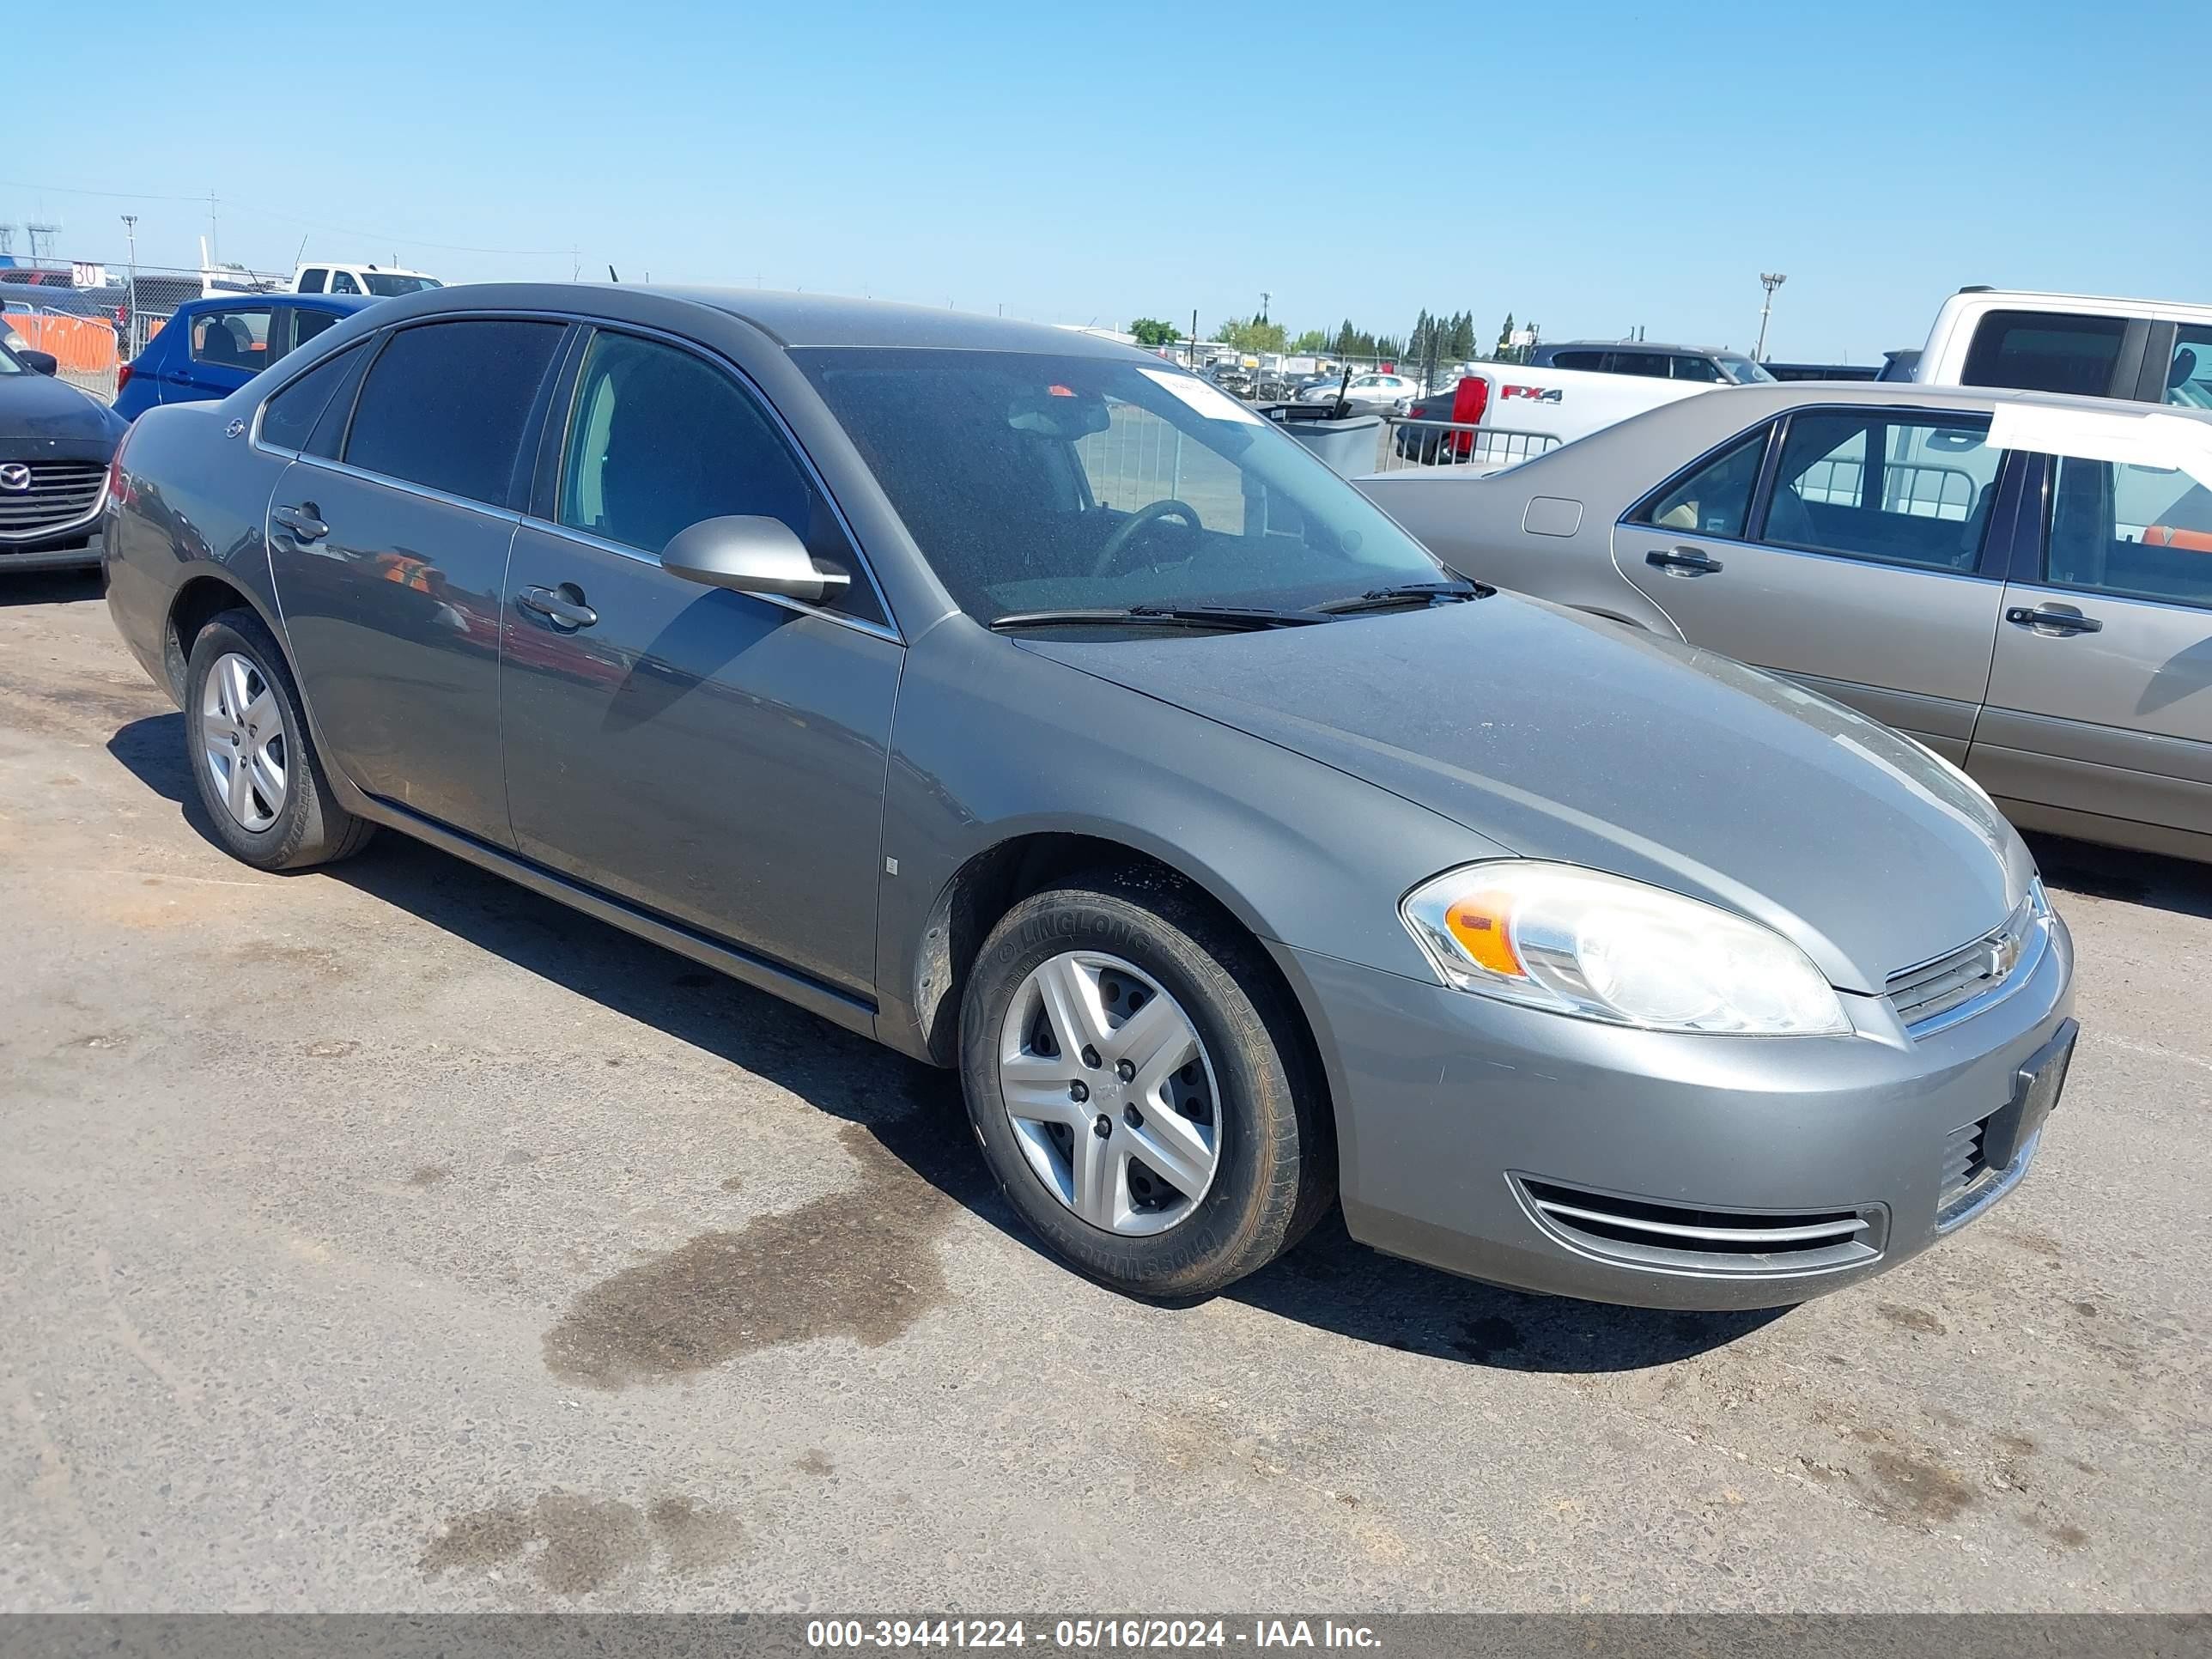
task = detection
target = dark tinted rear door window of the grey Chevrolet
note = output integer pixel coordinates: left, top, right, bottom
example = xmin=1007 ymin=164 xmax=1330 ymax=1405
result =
xmin=345 ymin=319 xmax=564 ymax=507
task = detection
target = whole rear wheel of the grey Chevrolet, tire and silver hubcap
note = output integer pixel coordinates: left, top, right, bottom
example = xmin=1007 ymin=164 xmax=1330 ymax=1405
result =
xmin=184 ymin=608 xmax=376 ymax=869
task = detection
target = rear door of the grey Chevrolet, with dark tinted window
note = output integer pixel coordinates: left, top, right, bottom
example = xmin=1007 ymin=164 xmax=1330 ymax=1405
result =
xmin=261 ymin=319 xmax=566 ymax=848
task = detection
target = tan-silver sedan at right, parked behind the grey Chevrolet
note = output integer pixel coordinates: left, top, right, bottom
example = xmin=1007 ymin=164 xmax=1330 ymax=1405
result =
xmin=1360 ymin=385 xmax=2212 ymax=858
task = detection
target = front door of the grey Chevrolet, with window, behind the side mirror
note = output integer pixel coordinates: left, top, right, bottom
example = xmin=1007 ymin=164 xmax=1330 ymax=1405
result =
xmin=500 ymin=330 xmax=905 ymax=995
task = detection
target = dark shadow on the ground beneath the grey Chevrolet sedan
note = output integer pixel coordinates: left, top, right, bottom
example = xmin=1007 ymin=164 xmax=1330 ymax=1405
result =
xmin=108 ymin=714 xmax=1778 ymax=1371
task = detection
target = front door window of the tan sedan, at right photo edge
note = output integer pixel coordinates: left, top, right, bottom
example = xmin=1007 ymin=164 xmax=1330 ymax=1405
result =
xmin=2044 ymin=456 xmax=2212 ymax=606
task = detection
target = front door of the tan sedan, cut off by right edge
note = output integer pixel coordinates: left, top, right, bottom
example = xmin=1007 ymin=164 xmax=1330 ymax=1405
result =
xmin=1966 ymin=456 xmax=2212 ymax=849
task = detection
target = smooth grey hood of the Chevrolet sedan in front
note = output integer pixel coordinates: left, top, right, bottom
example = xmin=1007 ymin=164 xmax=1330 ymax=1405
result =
xmin=1029 ymin=595 xmax=2035 ymax=994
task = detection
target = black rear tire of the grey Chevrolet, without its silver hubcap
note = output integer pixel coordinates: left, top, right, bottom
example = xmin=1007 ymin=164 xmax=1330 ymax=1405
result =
xmin=184 ymin=608 xmax=376 ymax=869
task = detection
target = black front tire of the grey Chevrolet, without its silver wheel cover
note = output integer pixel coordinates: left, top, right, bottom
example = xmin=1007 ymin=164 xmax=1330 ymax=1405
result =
xmin=960 ymin=872 xmax=1336 ymax=1298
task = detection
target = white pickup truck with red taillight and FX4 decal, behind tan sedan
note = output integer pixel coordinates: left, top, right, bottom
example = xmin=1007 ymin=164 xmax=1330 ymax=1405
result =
xmin=1395 ymin=288 xmax=2212 ymax=469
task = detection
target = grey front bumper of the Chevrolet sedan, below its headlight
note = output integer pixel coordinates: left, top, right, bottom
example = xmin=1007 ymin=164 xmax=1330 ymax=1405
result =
xmin=1276 ymin=915 xmax=2073 ymax=1310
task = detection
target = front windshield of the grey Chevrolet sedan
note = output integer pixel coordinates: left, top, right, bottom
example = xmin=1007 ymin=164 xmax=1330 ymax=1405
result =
xmin=792 ymin=349 xmax=1447 ymax=622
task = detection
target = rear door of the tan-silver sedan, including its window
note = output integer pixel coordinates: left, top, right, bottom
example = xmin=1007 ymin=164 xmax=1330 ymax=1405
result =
xmin=1613 ymin=407 xmax=2004 ymax=761
